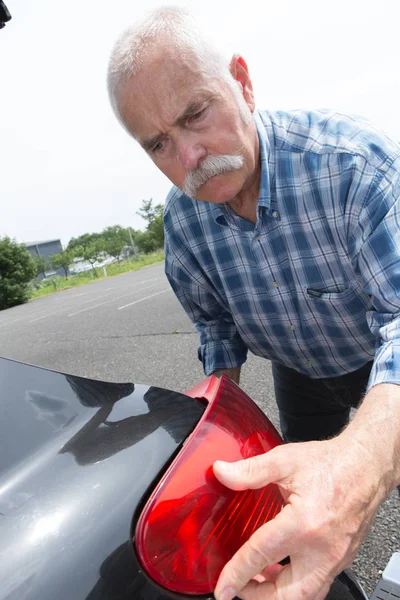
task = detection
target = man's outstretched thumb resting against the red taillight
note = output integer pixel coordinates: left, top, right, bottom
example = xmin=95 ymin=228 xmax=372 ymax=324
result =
xmin=213 ymin=445 xmax=294 ymax=490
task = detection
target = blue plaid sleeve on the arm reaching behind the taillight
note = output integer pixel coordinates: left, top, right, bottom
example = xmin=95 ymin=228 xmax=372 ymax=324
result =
xmin=165 ymin=240 xmax=247 ymax=375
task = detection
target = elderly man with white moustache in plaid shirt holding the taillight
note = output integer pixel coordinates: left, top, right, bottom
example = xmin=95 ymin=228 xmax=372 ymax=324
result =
xmin=108 ymin=9 xmax=400 ymax=600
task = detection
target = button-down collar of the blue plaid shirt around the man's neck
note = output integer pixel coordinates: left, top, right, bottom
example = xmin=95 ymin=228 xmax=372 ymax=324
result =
xmin=210 ymin=109 xmax=271 ymax=225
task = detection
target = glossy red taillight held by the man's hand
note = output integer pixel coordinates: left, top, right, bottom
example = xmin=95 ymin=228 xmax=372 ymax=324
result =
xmin=135 ymin=376 xmax=283 ymax=594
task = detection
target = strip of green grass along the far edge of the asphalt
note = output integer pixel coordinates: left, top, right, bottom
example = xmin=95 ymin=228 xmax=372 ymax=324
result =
xmin=30 ymin=250 xmax=164 ymax=300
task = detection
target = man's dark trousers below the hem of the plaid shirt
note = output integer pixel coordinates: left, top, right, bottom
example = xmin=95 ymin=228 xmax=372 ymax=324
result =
xmin=272 ymin=361 xmax=372 ymax=442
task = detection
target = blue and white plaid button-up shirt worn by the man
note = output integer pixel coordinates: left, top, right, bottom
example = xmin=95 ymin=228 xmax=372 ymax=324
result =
xmin=165 ymin=111 xmax=400 ymax=387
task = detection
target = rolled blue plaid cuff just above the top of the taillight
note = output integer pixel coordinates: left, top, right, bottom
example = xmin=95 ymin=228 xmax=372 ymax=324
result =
xmin=198 ymin=340 xmax=247 ymax=375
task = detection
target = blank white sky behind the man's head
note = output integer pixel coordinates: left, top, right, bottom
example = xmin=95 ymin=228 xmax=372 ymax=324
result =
xmin=0 ymin=0 xmax=400 ymax=244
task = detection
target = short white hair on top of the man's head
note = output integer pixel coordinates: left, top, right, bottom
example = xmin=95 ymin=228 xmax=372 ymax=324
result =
xmin=107 ymin=7 xmax=249 ymax=127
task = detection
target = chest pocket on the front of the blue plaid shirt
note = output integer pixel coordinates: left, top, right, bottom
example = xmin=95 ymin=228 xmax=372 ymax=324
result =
xmin=303 ymin=283 xmax=372 ymax=326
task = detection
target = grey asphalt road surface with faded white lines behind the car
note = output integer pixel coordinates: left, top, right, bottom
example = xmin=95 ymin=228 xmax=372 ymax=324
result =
xmin=0 ymin=264 xmax=400 ymax=594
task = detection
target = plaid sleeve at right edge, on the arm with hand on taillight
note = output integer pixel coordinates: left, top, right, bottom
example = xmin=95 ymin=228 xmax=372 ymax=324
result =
xmin=351 ymin=158 xmax=400 ymax=389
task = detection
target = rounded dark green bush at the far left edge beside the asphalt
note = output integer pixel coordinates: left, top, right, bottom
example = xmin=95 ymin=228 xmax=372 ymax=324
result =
xmin=0 ymin=237 xmax=37 ymax=310
